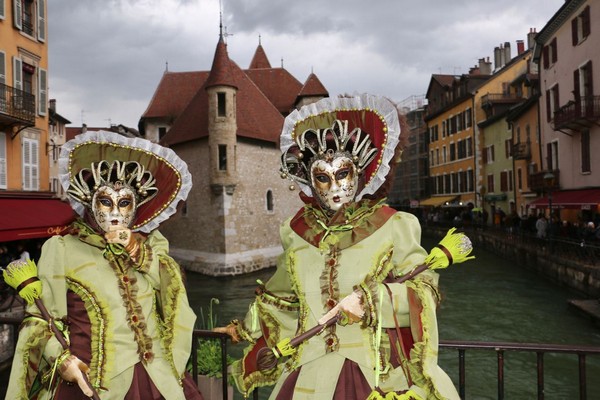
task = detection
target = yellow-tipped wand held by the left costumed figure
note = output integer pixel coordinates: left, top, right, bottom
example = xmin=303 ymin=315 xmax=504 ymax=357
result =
xmin=2 ymin=260 xmax=100 ymax=400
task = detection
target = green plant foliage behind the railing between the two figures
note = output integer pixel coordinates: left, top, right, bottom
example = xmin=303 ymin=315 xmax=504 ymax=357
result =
xmin=187 ymin=297 xmax=234 ymax=378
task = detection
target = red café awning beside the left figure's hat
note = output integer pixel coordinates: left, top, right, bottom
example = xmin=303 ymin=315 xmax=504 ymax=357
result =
xmin=0 ymin=198 xmax=75 ymax=242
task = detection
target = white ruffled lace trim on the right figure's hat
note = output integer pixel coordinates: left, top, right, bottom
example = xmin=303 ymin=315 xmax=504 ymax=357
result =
xmin=280 ymin=93 xmax=400 ymax=201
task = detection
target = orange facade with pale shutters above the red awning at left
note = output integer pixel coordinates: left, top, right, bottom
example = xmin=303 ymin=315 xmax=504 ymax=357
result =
xmin=0 ymin=0 xmax=49 ymax=191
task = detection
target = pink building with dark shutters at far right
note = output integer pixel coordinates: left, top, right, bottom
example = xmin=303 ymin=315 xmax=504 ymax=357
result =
xmin=532 ymin=0 xmax=600 ymax=220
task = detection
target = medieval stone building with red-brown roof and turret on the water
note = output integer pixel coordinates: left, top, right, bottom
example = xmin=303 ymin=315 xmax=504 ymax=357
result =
xmin=139 ymin=35 xmax=328 ymax=275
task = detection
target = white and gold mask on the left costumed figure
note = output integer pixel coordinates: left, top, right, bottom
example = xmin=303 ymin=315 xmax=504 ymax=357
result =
xmin=92 ymin=186 xmax=137 ymax=232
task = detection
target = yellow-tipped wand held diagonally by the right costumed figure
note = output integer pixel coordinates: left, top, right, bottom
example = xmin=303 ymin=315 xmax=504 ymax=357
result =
xmin=256 ymin=228 xmax=475 ymax=371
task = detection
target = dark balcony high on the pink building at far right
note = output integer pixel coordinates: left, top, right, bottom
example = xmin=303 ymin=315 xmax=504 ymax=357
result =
xmin=552 ymin=96 xmax=600 ymax=131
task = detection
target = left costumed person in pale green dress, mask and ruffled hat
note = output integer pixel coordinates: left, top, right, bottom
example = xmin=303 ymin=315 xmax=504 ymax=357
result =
xmin=6 ymin=131 xmax=202 ymax=400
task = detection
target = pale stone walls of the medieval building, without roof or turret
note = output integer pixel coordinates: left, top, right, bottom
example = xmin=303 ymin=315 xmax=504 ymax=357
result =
xmin=160 ymin=139 xmax=302 ymax=275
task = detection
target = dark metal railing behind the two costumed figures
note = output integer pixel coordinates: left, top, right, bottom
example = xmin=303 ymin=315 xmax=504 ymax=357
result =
xmin=0 ymin=317 xmax=600 ymax=400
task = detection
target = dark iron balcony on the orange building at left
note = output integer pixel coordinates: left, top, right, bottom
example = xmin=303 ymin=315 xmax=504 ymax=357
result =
xmin=0 ymin=83 xmax=35 ymax=128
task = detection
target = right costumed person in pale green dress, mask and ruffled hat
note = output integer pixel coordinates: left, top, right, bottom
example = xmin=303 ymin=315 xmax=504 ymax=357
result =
xmin=221 ymin=94 xmax=459 ymax=400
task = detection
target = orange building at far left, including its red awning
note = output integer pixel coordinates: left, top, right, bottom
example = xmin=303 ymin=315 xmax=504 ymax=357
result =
xmin=0 ymin=0 xmax=72 ymax=242
